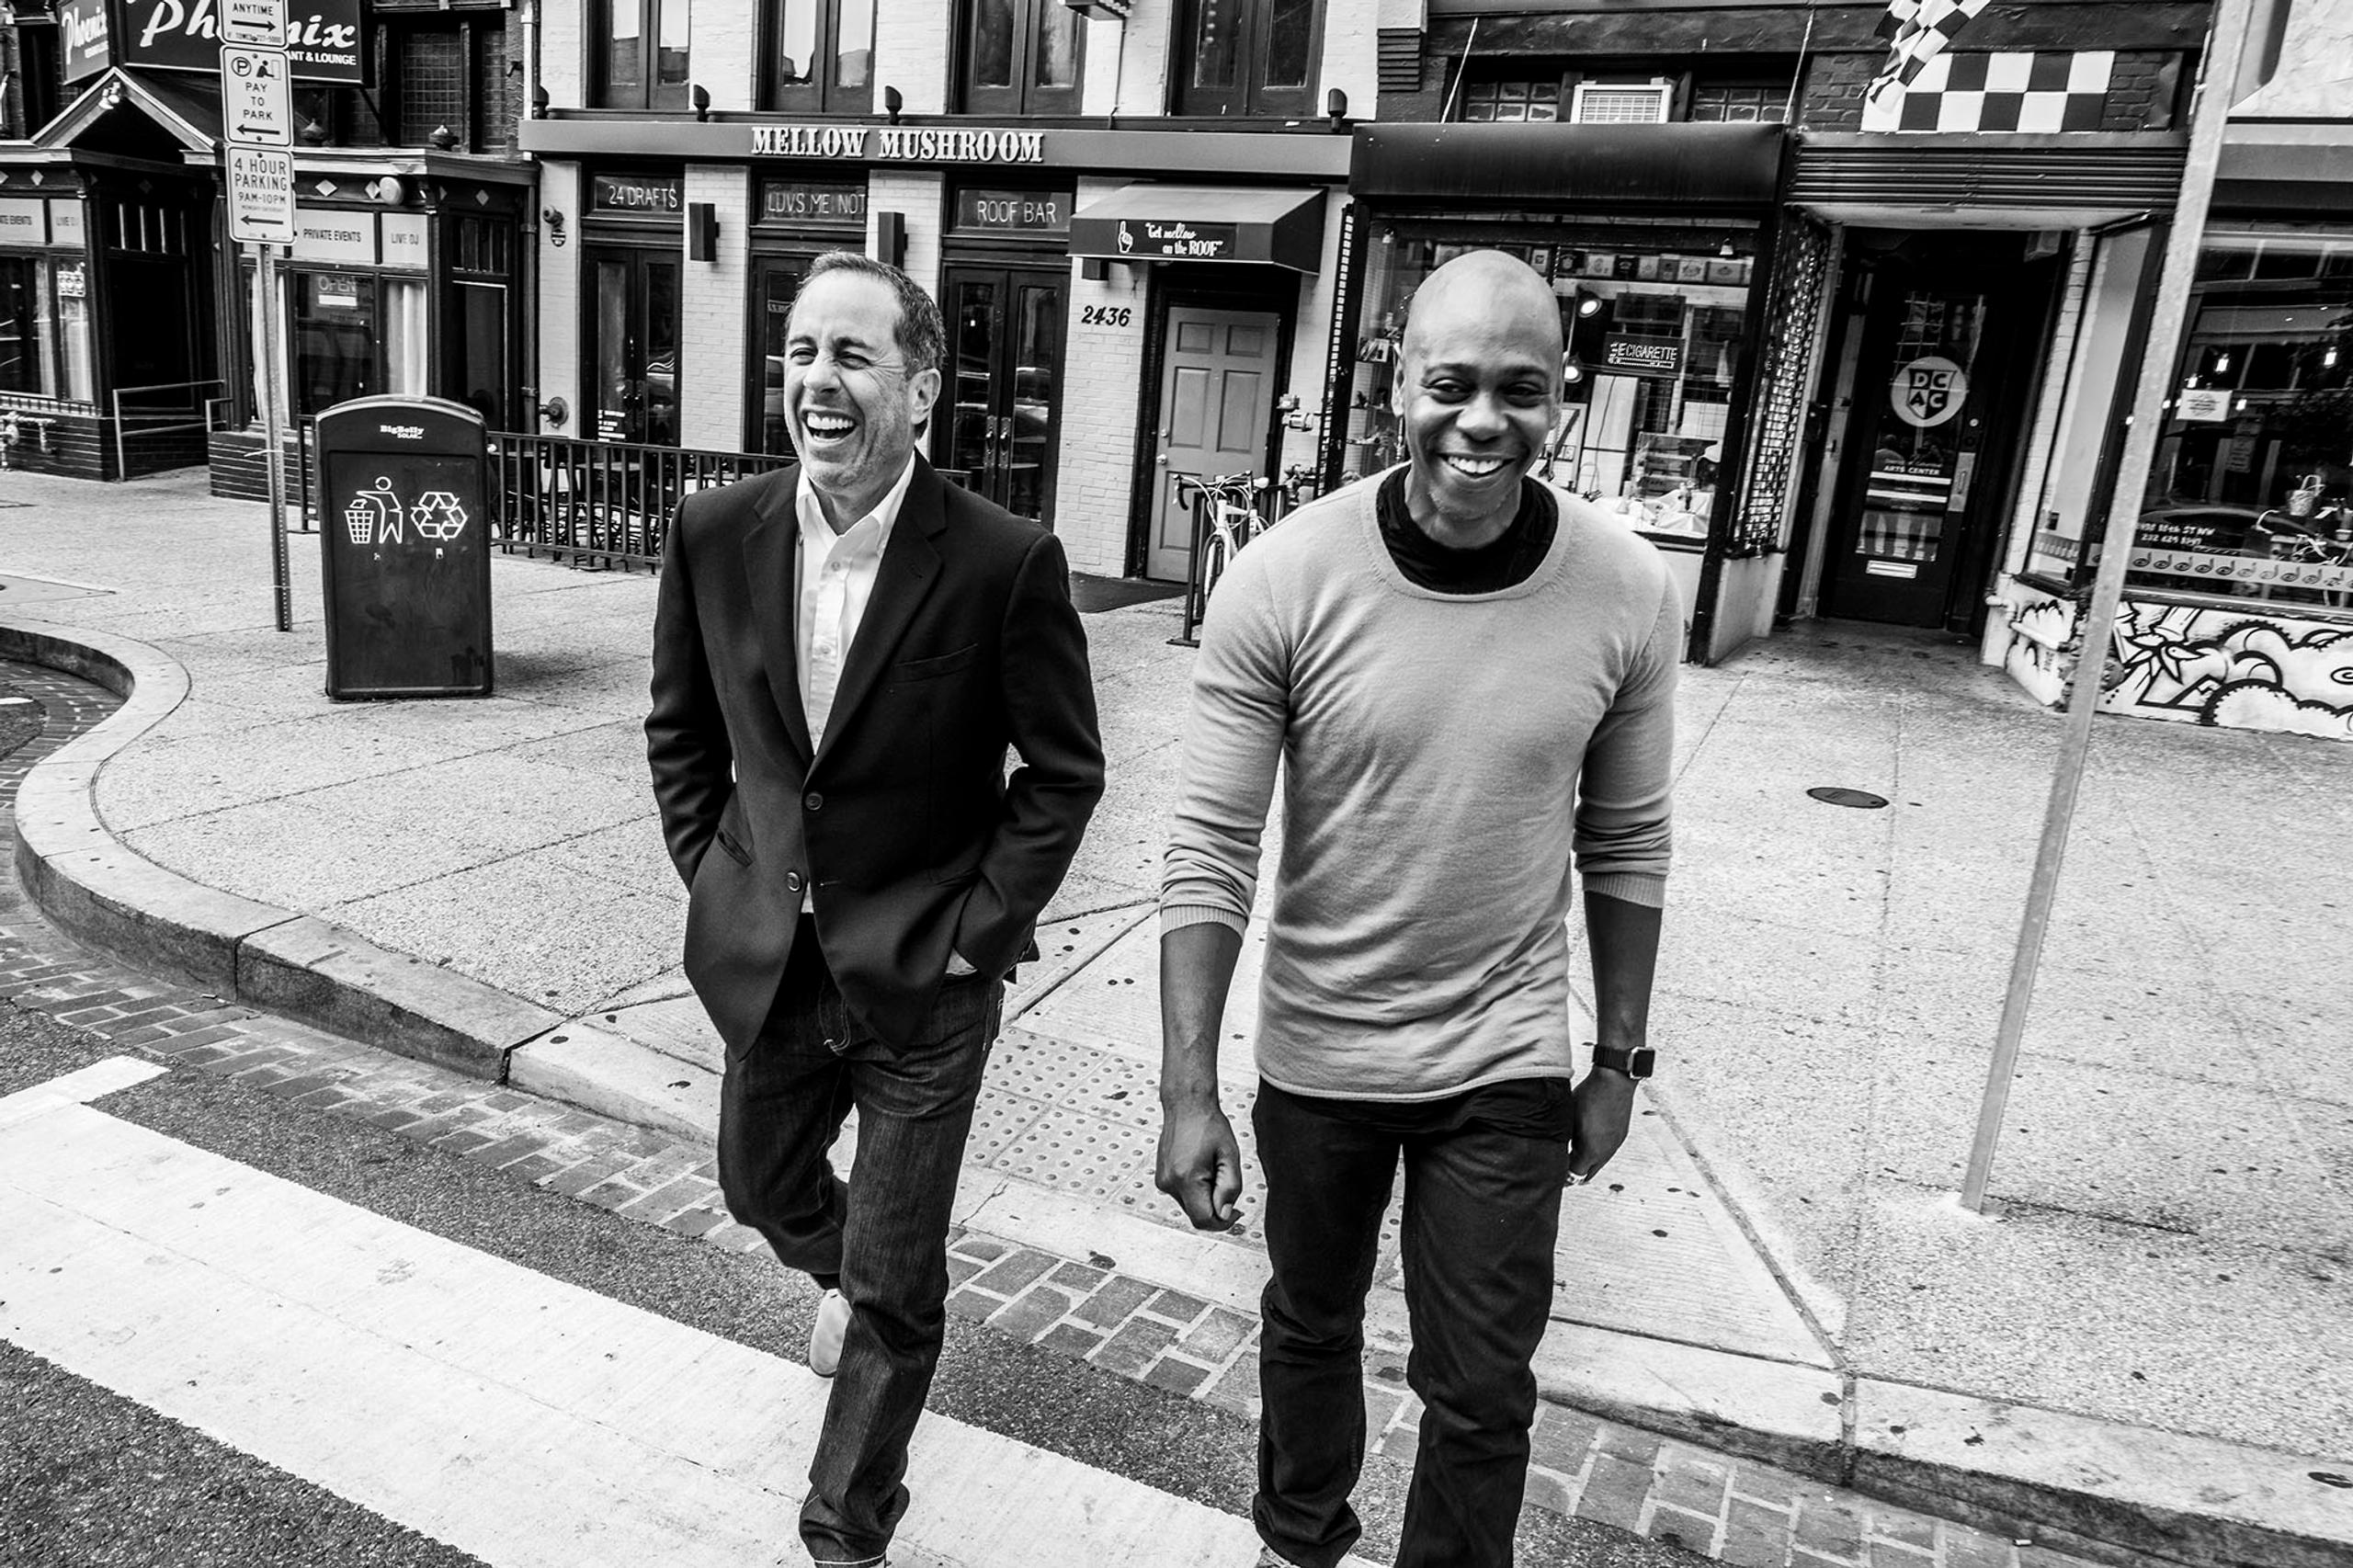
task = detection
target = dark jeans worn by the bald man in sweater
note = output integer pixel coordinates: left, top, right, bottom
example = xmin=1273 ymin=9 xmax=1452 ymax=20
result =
xmin=1249 ymin=1078 xmax=1572 ymax=1568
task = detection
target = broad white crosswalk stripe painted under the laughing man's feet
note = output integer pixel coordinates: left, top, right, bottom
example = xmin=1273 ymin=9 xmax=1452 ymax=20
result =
xmin=0 ymin=1068 xmax=1326 ymax=1568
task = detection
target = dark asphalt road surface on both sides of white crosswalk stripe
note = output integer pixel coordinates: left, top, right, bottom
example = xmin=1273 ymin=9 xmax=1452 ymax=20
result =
xmin=0 ymin=927 xmax=1703 ymax=1568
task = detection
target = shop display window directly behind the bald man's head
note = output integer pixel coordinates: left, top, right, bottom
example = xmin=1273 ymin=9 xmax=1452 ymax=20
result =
xmin=1344 ymin=219 xmax=1756 ymax=540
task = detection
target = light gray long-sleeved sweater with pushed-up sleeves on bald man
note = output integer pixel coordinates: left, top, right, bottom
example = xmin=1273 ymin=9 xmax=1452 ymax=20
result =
xmin=1160 ymin=475 xmax=1682 ymax=1099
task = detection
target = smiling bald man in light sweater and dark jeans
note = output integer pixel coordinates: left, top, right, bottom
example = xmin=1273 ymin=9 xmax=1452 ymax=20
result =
xmin=1158 ymin=252 xmax=1682 ymax=1568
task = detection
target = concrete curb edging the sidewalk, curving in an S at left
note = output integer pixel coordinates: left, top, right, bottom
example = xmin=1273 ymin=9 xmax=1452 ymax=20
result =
xmin=0 ymin=624 xmax=2353 ymax=1568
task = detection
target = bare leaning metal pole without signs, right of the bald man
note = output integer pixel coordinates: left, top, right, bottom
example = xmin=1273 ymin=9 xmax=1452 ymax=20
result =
xmin=1960 ymin=0 xmax=2254 ymax=1212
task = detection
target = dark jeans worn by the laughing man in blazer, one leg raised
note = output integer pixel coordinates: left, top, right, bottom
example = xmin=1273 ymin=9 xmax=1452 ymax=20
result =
xmin=720 ymin=930 xmax=1005 ymax=1563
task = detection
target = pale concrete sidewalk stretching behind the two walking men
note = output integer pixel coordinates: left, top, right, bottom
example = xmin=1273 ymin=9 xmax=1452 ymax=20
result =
xmin=0 ymin=473 xmax=2353 ymax=1565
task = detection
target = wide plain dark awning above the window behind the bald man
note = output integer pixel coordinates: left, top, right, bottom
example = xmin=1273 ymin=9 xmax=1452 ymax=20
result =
xmin=1348 ymin=122 xmax=1781 ymax=212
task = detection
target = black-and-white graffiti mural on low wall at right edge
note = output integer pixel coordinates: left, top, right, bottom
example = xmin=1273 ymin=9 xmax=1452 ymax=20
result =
xmin=2101 ymin=600 xmax=2353 ymax=739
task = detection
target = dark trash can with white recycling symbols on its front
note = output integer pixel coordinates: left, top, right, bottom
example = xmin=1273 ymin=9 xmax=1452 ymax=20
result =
xmin=315 ymin=398 xmax=489 ymax=701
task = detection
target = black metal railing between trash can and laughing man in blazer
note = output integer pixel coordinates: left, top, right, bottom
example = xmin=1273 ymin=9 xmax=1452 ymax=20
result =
xmin=489 ymin=431 xmax=793 ymax=567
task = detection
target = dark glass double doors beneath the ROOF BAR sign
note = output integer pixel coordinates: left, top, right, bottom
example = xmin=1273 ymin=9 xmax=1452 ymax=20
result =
xmin=932 ymin=266 xmax=1063 ymax=523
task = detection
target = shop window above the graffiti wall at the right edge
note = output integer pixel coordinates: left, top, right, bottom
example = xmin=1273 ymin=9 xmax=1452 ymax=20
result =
xmin=2130 ymin=223 xmax=2353 ymax=609
